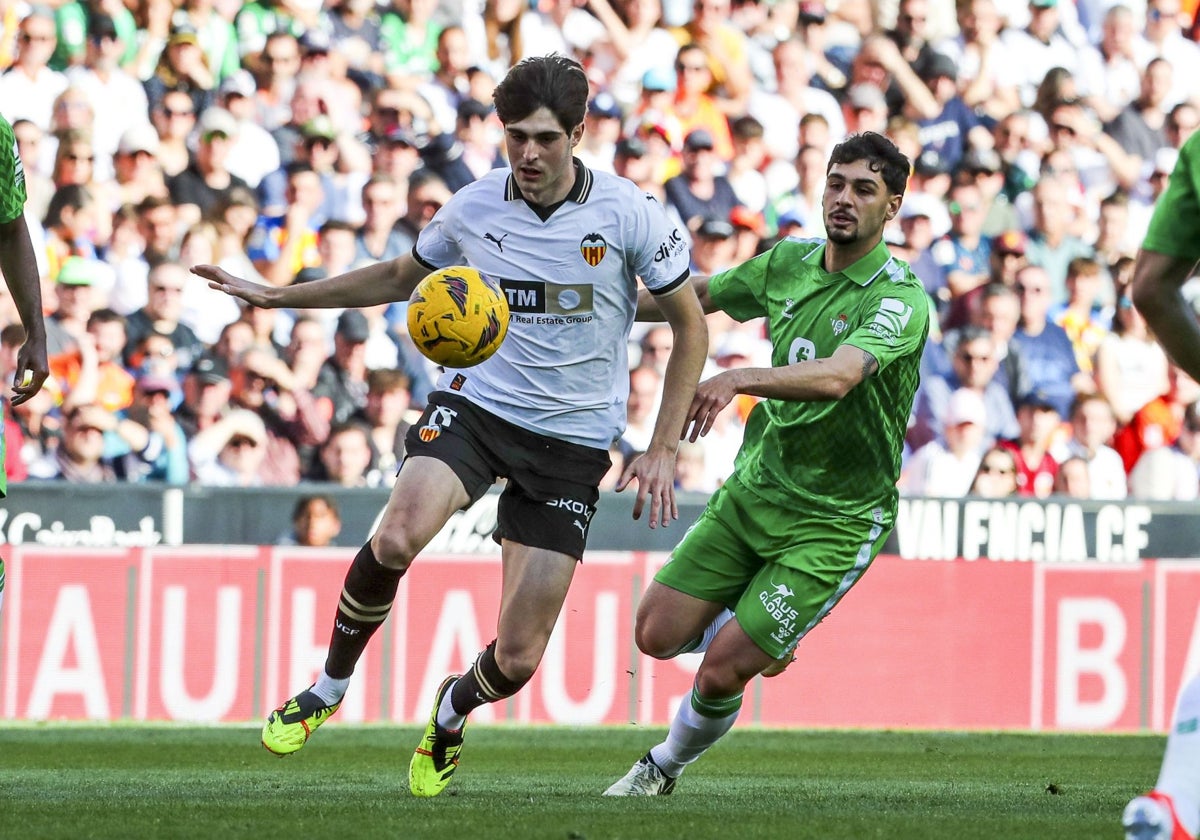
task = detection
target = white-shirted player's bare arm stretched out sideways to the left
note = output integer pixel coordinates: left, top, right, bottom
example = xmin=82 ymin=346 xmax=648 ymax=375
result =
xmin=192 ymin=253 xmax=427 ymax=310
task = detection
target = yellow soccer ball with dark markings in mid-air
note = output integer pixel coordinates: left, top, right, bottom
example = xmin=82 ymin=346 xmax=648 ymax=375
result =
xmin=408 ymin=265 xmax=509 ymax=367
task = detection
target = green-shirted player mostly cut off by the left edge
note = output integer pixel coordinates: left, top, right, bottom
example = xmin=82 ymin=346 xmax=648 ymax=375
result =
xmin=0 ymin=114 xmax=50 ymax=619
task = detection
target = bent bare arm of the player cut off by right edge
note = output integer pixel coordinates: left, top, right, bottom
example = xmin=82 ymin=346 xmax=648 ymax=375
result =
xmin=1133 ymin=248 xmax=1200 ymax=379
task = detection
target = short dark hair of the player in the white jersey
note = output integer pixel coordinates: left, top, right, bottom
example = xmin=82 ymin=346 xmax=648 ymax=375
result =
xmin=492 ymin=53 xmax=589 ymax=133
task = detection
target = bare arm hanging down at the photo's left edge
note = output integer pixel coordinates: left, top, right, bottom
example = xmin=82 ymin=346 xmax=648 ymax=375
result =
xmin=0 ymin=215 xmax=50 ymax=406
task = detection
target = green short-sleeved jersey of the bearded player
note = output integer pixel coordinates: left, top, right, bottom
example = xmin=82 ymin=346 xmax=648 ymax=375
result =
xmin=708 ymin=239 xmax=929 ymax=523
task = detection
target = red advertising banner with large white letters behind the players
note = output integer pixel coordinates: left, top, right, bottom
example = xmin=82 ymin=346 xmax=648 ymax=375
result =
xmin=0 ymin=546 xmax=1200 ymax=731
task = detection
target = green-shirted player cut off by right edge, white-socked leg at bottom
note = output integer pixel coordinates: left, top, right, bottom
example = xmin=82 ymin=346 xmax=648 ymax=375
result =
xmin=1122 ymin=133 xmax=1200 ymax=840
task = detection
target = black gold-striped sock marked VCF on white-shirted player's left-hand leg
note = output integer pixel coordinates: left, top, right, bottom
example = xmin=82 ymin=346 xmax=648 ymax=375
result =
xmin=325 ymin=542 xmax=404 ymax=679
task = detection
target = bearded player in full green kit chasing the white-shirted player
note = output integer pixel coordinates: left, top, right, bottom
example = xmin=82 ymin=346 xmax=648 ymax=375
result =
xmin=605 ymin=132 xmax=929 ymax=796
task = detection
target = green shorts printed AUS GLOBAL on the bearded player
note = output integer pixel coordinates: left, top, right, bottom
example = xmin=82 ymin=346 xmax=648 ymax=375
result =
xmin=654 ymin=475 xmax=892 ymax=659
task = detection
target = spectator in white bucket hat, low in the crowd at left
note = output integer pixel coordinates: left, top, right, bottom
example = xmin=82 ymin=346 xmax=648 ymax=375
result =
xmin=187 ymin=408 xmax=270 ymax=487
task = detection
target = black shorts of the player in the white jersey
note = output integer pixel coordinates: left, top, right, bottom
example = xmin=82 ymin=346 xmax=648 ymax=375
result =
xmin=404 ymin=391 xmax=612 ymax=559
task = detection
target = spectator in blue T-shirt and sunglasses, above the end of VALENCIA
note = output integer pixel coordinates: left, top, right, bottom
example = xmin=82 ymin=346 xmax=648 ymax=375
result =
xmin=1013 ymin=265 xmax=1096 ymax=415
